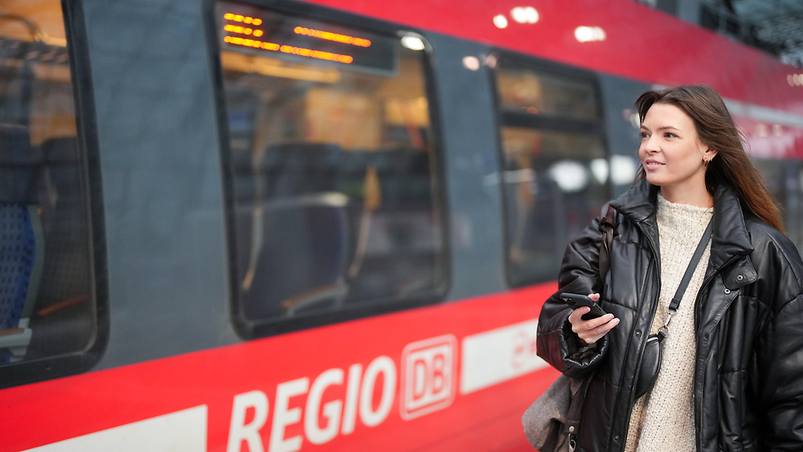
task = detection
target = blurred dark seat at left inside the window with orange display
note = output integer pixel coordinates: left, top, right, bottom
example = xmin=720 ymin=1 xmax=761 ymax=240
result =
xmin=243 ymin=192 xmax=350 ymax=319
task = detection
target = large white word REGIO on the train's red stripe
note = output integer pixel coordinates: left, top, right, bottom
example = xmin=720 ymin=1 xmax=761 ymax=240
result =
xmin=226 ymin=356 xmax=397 ymax=452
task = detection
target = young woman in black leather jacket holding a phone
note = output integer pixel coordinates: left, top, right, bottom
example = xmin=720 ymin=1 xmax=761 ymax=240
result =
xmin=538 ymin=86 xmax=803 ymax=452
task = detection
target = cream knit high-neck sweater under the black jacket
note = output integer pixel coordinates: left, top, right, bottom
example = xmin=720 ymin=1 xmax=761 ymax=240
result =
xmin=625 ymin=195 xmax=714 ymax=452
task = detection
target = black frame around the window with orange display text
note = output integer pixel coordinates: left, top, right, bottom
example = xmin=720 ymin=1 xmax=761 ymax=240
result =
xmin=203 ymin=0 xmax=452 ymax=339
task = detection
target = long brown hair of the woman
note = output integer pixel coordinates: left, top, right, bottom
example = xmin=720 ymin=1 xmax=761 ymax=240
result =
xmin=636 ymin=86 xmax=783 ymax=232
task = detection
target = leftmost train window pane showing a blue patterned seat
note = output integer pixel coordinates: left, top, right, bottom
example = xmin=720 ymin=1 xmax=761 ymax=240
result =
xmin=0 ymin=0 xmax=99 ymax=386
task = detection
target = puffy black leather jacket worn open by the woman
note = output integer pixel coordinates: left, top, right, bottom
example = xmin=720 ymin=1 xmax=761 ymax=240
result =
xmin=537 ymin=180 xmax=803 ymax=452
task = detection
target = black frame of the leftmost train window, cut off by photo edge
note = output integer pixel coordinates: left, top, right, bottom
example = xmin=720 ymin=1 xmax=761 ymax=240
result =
xmin=0 ymin=0 xmax=109 ymax=388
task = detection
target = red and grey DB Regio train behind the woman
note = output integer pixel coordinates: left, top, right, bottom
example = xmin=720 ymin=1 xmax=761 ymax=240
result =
xmin=0 ymin=0 xmax=803 ymax=452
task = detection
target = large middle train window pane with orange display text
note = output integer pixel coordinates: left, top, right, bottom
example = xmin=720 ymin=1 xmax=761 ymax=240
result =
xmin=213 ymin=1 xmax=447 ymax=337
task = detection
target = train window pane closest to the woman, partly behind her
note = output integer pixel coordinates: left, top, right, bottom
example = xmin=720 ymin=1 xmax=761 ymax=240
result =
xmin=495 ymin=56 xmax=610 ymax=286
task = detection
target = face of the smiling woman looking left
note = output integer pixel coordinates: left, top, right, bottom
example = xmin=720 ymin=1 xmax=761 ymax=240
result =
xmin=639 ymin=103 xmax=716 ymax=203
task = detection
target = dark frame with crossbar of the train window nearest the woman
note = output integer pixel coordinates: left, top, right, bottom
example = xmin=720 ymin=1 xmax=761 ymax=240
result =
xmin=490 ymin=49 xmax=613 ymax=288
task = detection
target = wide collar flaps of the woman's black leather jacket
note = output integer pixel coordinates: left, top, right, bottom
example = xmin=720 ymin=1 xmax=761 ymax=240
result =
xmin=611 ymin=179 xmax=753 ymax=269
